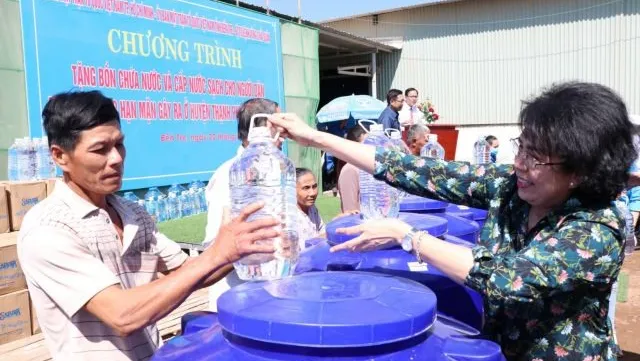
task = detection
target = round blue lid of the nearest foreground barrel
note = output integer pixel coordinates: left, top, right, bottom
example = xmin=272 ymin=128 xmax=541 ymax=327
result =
xmin=218 ymin=272 xmax=436 ymax=348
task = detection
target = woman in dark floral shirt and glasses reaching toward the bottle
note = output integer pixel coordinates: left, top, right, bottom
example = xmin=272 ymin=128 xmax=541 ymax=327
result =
xmin=271 ymin=83 xmax=636 ymax=361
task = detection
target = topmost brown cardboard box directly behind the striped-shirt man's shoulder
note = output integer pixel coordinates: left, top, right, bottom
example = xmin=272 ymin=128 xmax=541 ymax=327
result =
xmin=4 ymin=182 xmax=47 ymax=231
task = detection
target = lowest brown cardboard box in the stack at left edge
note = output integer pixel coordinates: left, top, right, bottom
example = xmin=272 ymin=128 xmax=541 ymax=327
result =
xmin=0 ymin=290 xmax=31 ymax=345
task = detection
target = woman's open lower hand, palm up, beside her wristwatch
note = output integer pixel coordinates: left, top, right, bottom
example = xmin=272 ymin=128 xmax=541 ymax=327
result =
xmin=331 ymin=219 xmax=411 ymax=252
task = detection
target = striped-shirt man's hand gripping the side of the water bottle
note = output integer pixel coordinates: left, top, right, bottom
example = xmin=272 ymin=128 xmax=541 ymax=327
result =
xmin=205 ymin=202 xmax=282 ymax=264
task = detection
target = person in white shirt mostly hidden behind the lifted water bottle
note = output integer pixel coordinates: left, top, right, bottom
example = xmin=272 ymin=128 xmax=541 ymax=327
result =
xmin=202 ymin=98 xmax=282 ymax=311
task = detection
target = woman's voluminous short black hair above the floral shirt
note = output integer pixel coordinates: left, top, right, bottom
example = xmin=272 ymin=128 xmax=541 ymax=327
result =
xmin=520 ymin=82 xmax=637 ymax=205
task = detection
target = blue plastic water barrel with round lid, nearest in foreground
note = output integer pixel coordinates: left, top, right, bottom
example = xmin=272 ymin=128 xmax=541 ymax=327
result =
xmin=152 ymin=272 xmax=504 ymax=361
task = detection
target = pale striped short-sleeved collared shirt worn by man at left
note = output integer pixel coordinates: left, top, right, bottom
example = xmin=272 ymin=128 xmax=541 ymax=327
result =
xmin=18 ymin=182 xmax=187 ymax=361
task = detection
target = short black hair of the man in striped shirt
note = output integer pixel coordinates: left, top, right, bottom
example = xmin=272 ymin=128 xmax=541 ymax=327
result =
xmin=42 ymin=90 xmax=120 ymax=150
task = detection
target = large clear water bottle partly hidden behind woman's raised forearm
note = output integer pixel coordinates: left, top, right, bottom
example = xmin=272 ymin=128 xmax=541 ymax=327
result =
xmin=359 ymin=120 xmax=400 ymax=219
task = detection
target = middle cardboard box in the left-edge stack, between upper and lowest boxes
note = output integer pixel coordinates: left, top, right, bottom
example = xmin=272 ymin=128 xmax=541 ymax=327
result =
xmin=0 ymin=232 xmax=27 ymax=295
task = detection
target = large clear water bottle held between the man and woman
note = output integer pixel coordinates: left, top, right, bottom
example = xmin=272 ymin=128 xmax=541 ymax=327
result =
xmin=229 ymin=114 xmax=300 ymax=281
